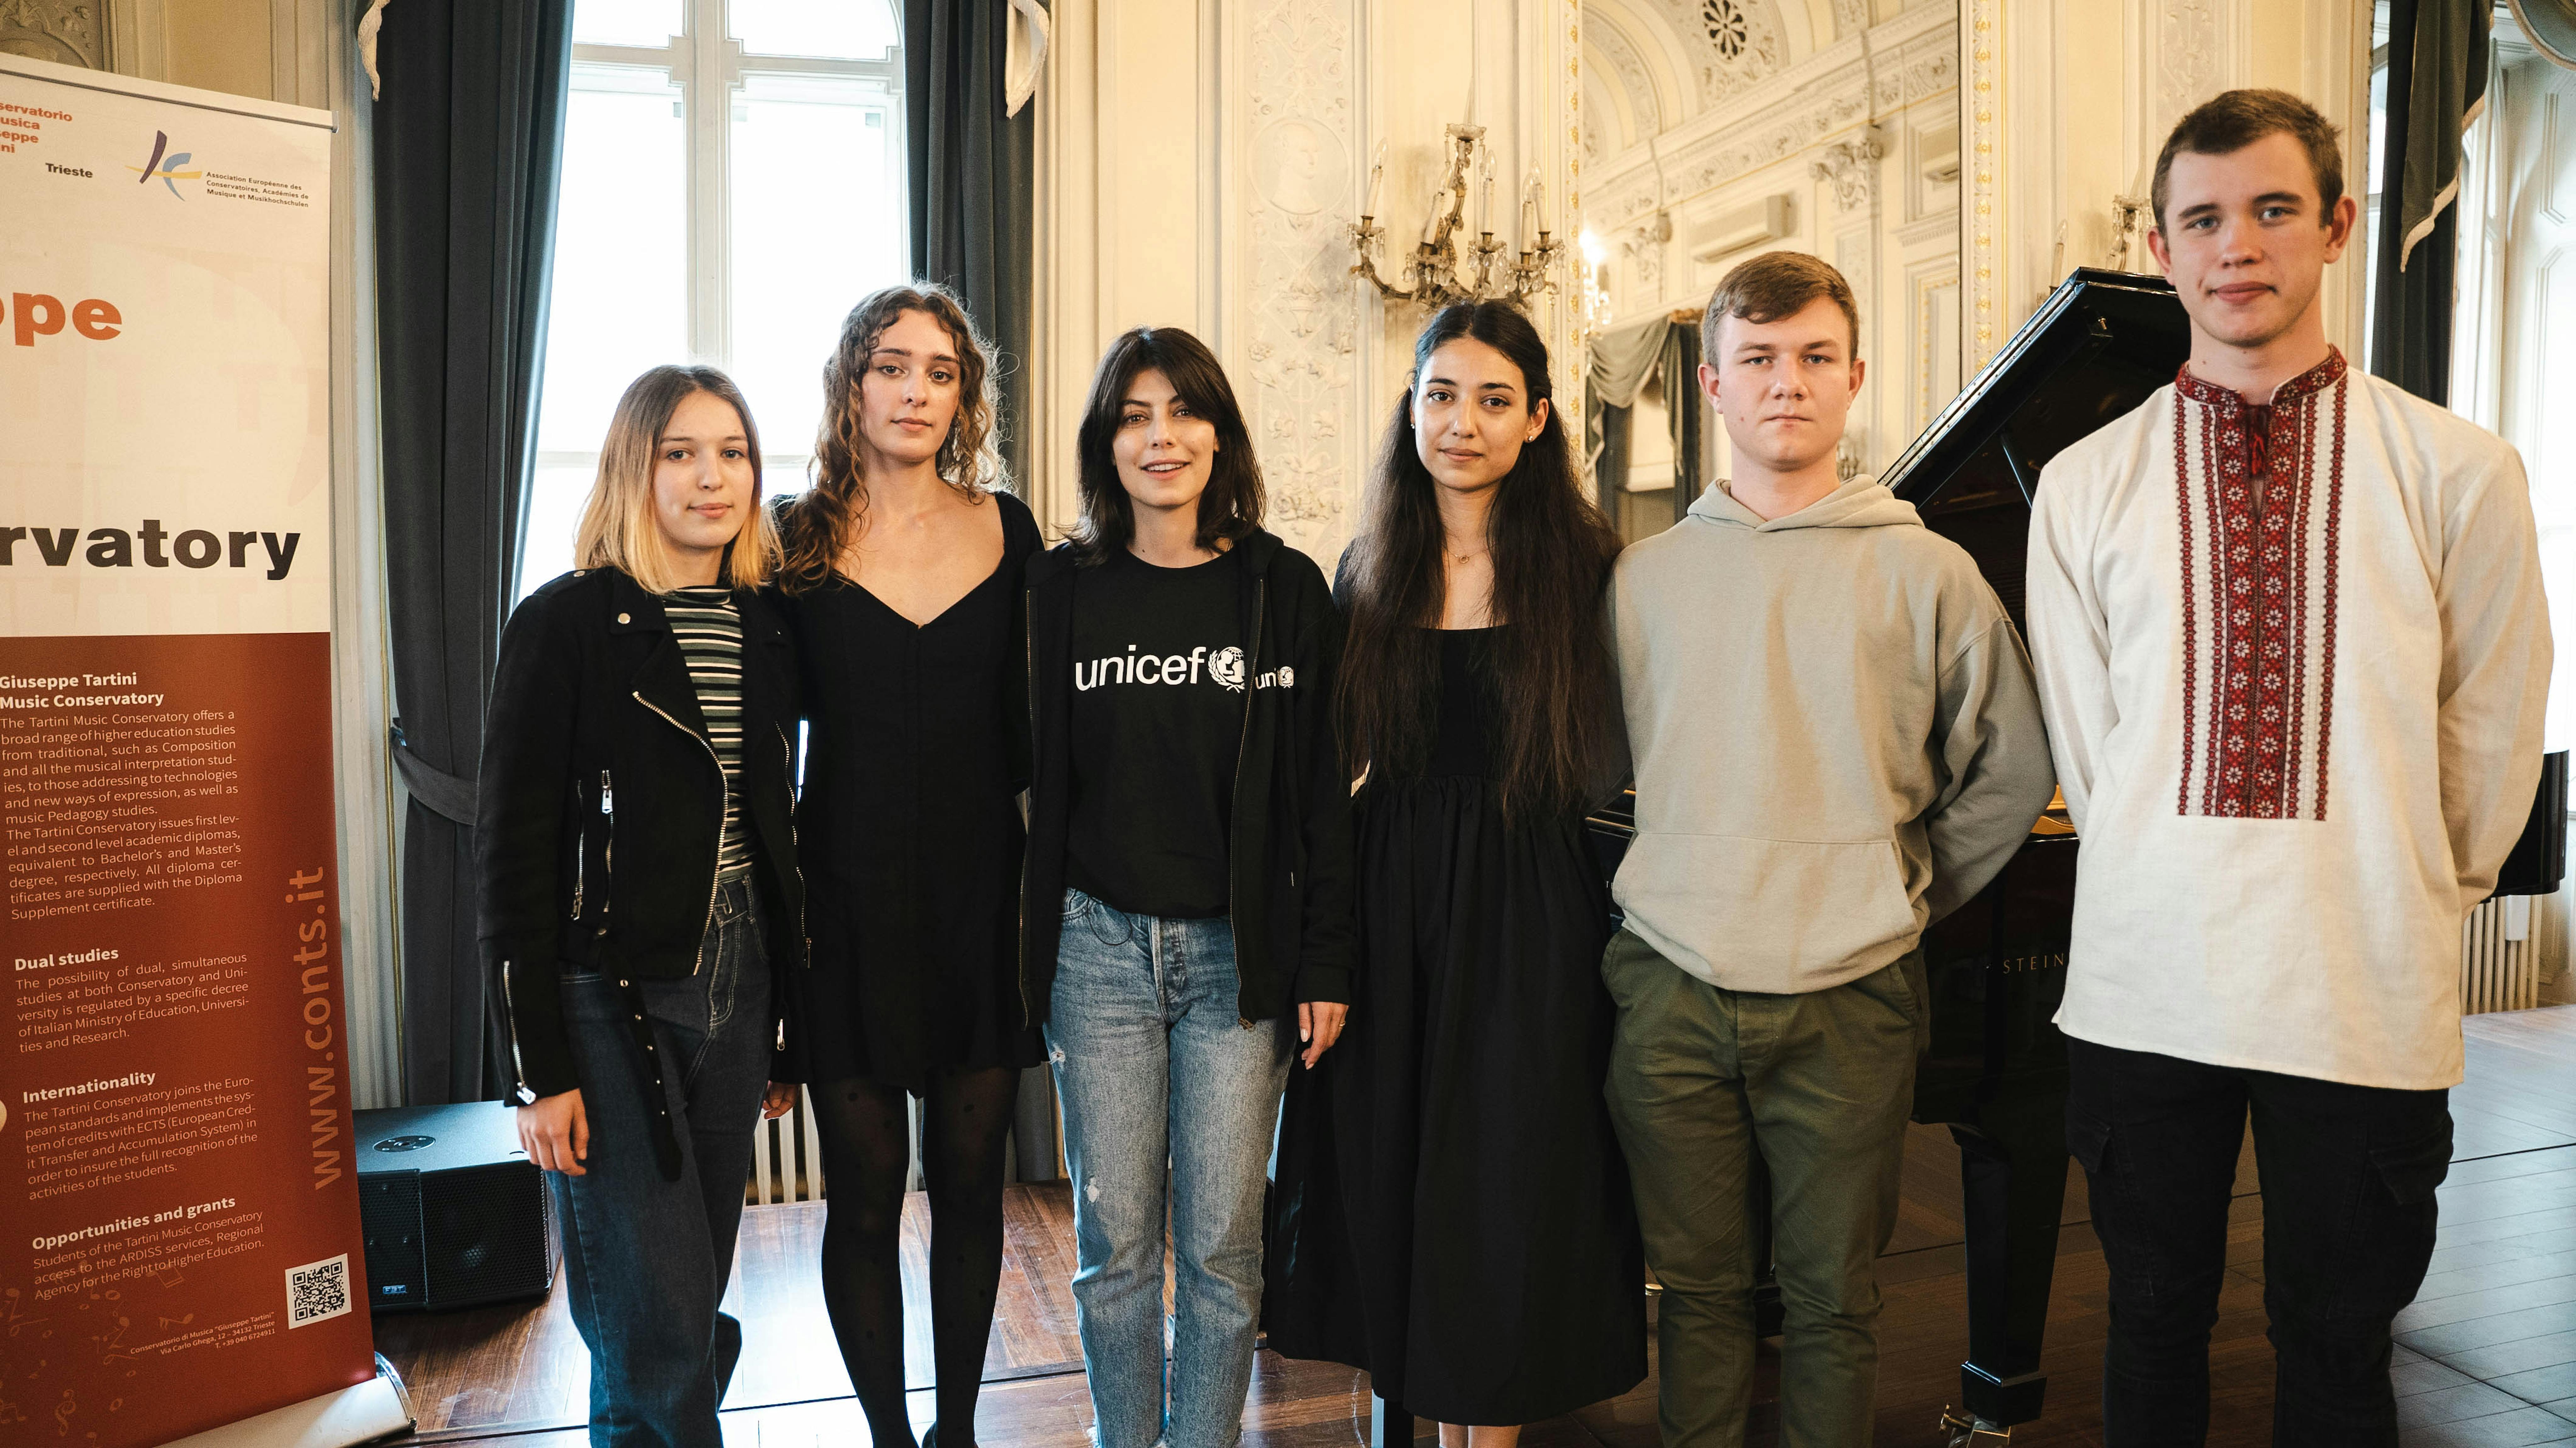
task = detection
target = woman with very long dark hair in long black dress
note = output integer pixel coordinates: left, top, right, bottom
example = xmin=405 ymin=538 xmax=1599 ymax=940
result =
xmin=1270 ymin=301 xmax=1646 ymax=1448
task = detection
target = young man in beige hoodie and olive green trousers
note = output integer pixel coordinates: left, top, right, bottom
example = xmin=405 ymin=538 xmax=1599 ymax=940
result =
xmin=1602 ymin=252 xmax=2056 ymax=1448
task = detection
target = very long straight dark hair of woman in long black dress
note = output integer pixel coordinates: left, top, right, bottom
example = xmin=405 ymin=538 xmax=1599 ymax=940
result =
xmin=1334 ymin=301 xmax=1618 ymax=819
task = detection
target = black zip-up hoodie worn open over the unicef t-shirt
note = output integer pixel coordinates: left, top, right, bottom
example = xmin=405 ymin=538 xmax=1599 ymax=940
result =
xmin=1020 ymin=528 xmax=1355 ymax=1023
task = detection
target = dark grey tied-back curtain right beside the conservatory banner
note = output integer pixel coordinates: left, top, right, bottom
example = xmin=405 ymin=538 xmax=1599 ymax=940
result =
xmin=376 ymin=0 xmax=572 ymax=1105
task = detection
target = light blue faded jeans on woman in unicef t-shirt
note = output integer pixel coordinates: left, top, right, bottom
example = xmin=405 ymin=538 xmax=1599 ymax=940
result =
xmin=1046 ymin=889 xmax=1296 ymax=1448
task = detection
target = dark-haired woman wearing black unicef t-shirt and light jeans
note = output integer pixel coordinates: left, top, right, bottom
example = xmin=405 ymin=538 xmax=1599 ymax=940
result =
xmin=1020 ymin=327 xmax=1352 ymax=1448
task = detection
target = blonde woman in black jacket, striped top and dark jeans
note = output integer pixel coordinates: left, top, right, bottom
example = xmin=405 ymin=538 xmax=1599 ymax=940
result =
xmin=474 ymin=366 xmax=804 ymax=1448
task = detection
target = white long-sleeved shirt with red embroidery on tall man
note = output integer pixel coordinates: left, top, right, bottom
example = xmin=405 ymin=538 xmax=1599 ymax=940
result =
xmin=2030 ymin=353 xmax=2550 ymax=1090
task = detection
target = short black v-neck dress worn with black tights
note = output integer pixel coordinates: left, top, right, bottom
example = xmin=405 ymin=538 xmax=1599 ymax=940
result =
xmin=791 ymin=492 xmax=1046 ymax=1092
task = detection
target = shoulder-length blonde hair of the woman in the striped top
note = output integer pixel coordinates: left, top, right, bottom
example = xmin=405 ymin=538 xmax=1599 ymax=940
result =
xmin=572 ymin=366 xmax=778 ymax=593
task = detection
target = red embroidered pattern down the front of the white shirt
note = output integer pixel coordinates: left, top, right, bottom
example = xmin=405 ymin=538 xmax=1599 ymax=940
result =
xmin=2174 ymin=353 xmax=2347 ymax=819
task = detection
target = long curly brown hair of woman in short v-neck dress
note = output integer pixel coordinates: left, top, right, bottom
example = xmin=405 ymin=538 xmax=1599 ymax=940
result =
xmin=778 ymin=281 xmax=1007 ymax=593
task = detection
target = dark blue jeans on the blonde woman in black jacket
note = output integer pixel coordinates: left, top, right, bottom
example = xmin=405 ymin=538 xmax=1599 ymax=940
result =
xmin=549 ymin=876 xmax=773 ymax=1448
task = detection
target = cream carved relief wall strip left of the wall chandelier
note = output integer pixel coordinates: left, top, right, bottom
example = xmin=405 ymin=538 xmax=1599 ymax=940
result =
xmin=1242 ymin=0 xmax=1360 ymax=536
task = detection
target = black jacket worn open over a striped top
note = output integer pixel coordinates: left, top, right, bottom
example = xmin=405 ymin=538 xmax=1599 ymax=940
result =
xmin=474 ymin=569 xmax=806 ymax=1100
